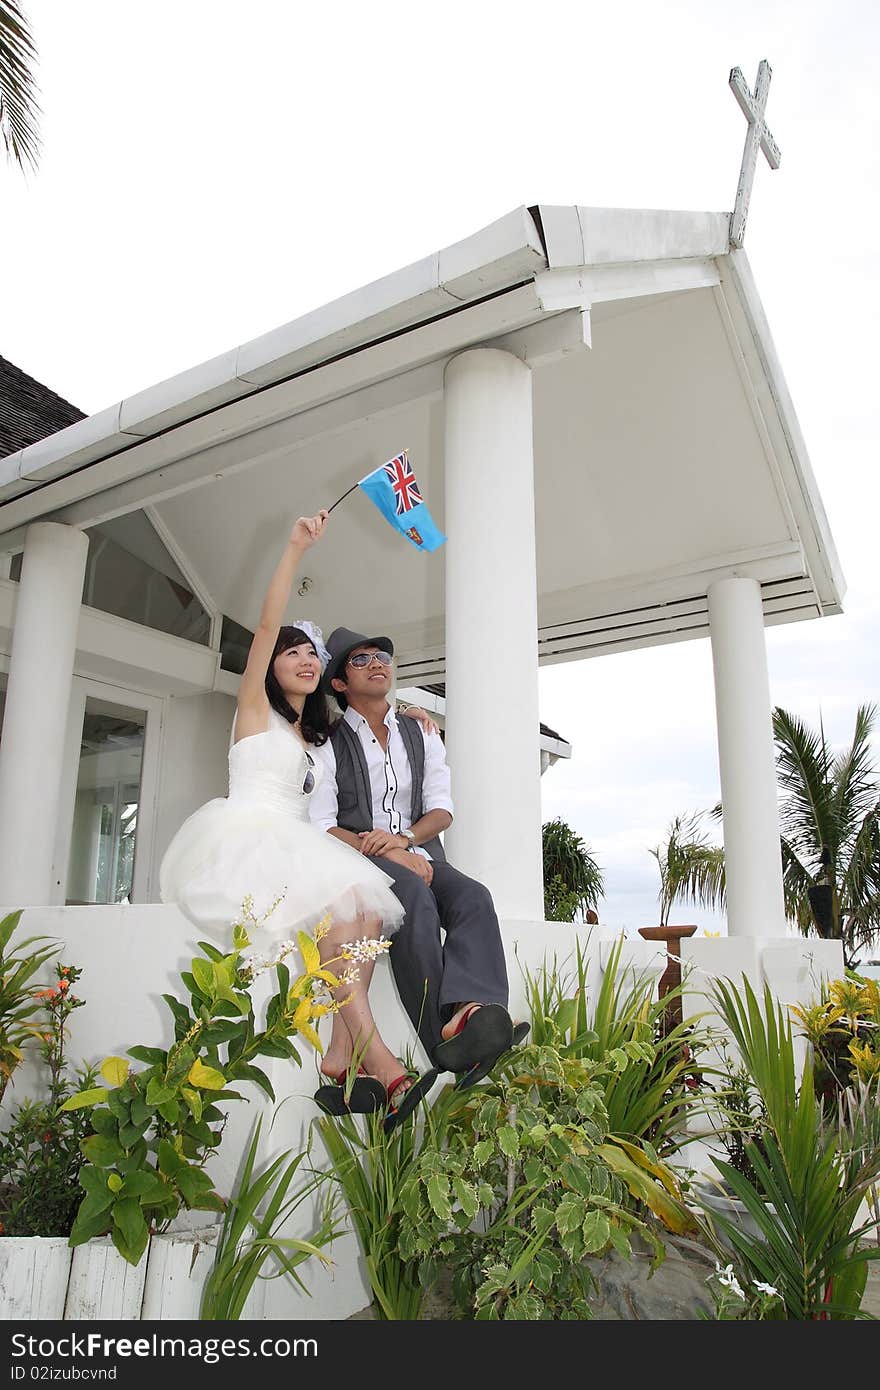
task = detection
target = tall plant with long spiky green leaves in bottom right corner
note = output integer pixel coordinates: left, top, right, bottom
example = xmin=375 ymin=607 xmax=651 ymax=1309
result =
xmin=700 ymin=977 xmax=880 ymax=1321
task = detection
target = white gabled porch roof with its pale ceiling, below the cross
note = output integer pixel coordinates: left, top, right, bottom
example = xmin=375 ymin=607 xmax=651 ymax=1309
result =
xmin=0 ymin=206 xmax=844 ymax=684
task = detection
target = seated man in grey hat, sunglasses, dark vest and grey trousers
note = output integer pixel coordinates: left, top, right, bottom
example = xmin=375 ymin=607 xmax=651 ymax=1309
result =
xmin=310 ymin=627 xmax=528 ymax=1088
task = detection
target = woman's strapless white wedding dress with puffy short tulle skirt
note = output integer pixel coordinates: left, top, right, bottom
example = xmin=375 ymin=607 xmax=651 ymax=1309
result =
xmin=158 ymin=709 xmax=403 ymax=949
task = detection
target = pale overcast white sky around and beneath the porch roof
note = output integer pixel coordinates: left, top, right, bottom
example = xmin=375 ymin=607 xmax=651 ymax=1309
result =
xmin=0 ymin=0 xmax=880 ymax=933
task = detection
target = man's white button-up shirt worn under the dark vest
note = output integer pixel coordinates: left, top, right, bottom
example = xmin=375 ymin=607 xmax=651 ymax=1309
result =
xmin=309 ymin=705 xmax=452 ymax=859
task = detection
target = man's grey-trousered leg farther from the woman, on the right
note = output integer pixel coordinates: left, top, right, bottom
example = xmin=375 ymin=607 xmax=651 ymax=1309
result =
xmin=431 ymin=863 xmax=509 ymax=1024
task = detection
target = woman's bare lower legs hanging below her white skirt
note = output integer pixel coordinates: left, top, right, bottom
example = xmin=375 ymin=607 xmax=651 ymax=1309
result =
xmin=318 ymin=917 xmax=407 ymax=1102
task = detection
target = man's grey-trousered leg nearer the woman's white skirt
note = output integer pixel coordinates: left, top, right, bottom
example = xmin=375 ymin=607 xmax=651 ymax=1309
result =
xmin=367 ymin=855 xmax=443 ymax=1059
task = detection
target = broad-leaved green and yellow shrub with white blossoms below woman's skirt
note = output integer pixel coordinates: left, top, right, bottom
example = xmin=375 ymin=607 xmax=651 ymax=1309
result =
xmin=63 ymin=898 xmax=388 ymax=1264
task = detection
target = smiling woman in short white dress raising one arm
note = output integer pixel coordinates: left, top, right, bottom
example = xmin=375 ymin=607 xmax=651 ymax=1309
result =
xmin=160 ymin=512 xmax=437 ymax=1129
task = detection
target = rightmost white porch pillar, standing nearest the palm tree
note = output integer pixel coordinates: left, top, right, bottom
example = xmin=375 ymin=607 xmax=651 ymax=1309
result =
xmin=709 ymin=578 xmax=787 ymax=937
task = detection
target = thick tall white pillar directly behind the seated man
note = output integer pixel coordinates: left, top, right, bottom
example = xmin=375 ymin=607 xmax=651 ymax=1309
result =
xmin=445 ymin=348 xmax=544 ymax=922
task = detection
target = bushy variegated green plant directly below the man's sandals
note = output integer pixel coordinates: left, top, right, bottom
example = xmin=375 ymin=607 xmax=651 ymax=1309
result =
xmin=399 ymin=1045 xmax=692 ymax=1321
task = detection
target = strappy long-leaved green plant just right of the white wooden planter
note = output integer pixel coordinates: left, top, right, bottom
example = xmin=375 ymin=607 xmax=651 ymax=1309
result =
xmin=199 ymin=1116 xmax=342 ymax=1322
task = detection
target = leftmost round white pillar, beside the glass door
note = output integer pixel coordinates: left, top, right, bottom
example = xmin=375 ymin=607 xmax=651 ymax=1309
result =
xmin=0 ymin=521 xmax=89 ymax=908
